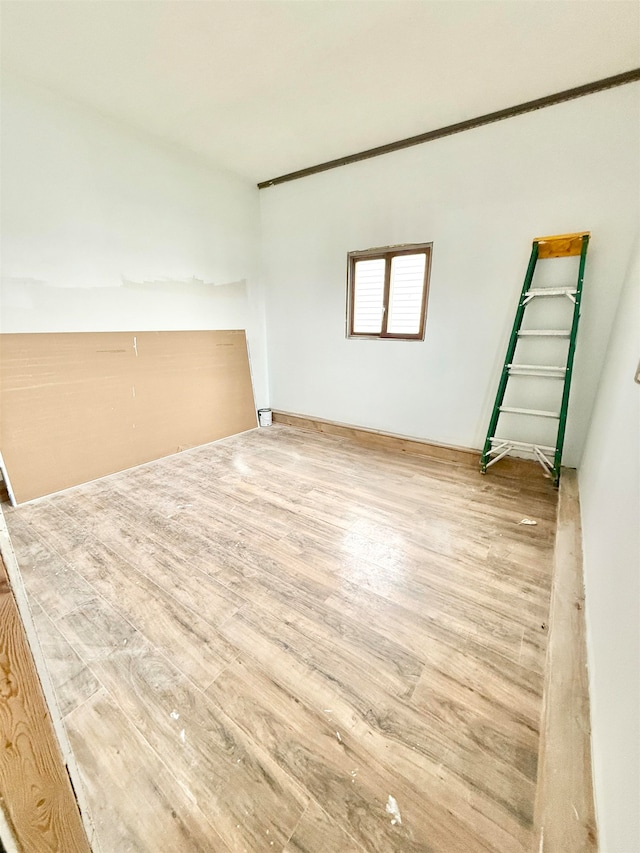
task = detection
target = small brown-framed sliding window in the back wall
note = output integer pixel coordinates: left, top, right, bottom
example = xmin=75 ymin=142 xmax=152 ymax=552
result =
xmin=347 ymin=243 xmax=431 ymax=341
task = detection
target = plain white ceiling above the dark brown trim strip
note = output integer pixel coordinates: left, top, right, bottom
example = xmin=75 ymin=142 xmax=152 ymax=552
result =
xmin=2 ymin=0 xmax=640 ymax=181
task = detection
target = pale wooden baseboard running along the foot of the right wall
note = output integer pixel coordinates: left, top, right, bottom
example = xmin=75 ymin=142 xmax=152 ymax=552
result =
xmin=533 ymin=469 xmax=598 ymax=853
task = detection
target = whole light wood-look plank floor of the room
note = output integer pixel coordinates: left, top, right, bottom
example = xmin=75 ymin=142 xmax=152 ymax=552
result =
xmin=1 ymin=425 xmax=556 ymax=853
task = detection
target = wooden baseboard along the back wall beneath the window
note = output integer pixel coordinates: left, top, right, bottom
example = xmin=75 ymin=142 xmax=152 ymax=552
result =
xmin=273 ymin=409 xmax=543 ymax=478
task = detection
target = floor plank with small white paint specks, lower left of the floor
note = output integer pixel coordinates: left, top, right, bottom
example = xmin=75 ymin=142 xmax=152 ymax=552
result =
xmin=53 ymin=599 xmax=308 ymax=851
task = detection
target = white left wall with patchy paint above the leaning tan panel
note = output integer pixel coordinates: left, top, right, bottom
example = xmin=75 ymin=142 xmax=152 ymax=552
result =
xmin=0 ymin=79 xmax=268 ymax=405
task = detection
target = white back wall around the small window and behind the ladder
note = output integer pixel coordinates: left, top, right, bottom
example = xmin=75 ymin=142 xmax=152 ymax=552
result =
xmin=260 ymin=84 xmax=640 ymax=465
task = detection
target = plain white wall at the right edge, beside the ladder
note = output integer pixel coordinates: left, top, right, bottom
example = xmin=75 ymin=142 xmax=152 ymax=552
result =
xmin=579 ymin=241 xmax=640 ymax=853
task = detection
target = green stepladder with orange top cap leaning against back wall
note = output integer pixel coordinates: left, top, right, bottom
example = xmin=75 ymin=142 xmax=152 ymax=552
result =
xmin=480 ymin=231 xmax=590 ymax=487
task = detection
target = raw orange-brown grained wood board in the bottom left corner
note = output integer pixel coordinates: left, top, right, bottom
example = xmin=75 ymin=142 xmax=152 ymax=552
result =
xmin=0 ymin=558 xmax=89 ymax=853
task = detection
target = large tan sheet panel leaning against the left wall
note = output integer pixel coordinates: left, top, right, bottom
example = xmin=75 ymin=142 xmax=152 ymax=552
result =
xmin=0 ymin=331 xmax=257 ymax=503
